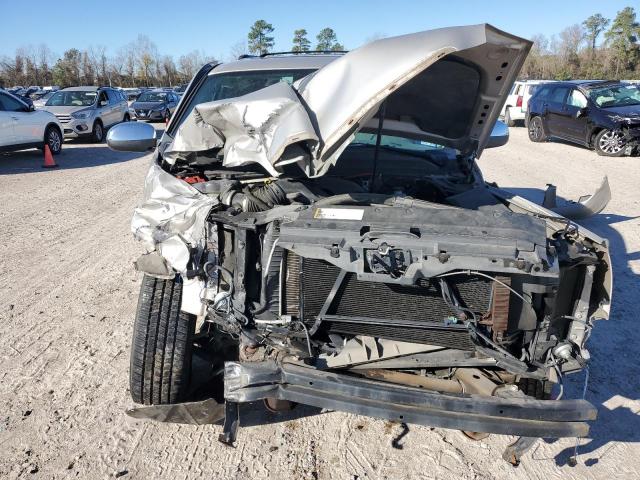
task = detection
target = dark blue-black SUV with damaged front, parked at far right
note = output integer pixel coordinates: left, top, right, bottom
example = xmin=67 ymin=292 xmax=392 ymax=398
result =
xmin=526 ymin=80 xmax=640 ymax=157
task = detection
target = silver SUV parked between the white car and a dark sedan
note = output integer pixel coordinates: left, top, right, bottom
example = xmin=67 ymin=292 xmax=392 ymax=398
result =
xmin=43 ymin=87 xmax=131 ymax=143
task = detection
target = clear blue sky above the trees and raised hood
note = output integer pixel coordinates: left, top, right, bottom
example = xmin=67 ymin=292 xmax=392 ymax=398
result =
xmin=0 ymin=0 xmax=640 ymax=59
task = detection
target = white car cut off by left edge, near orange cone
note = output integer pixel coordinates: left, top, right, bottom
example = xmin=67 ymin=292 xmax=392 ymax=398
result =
xmin=0 ymin=90 xmax=63 ymax=155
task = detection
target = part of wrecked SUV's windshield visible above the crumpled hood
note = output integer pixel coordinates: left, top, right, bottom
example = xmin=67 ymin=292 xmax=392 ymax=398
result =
xmin=180 ymin=69 xmax=315 ymax=127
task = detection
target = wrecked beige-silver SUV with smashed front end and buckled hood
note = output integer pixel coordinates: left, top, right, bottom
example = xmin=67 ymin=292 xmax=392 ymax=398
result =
xmin=108 ymin=25 xmax=611 ymax=462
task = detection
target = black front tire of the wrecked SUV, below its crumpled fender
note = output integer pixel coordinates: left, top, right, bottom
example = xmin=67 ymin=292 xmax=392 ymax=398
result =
xmin=129 ymin=275 xmax=196 ymax=405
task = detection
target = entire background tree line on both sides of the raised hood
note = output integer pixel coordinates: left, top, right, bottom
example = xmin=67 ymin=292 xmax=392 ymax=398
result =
xmin=0 ymin=7 xmax=640 ymax=87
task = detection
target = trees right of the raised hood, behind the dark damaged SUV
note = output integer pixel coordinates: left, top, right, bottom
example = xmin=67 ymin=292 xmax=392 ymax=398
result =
xmin=520 ymin=7 xmax=640 ymax=80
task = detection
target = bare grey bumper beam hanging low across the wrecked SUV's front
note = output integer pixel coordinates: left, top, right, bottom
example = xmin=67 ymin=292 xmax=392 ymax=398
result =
xmin=224 ymin=361 xmax=597 ymax=438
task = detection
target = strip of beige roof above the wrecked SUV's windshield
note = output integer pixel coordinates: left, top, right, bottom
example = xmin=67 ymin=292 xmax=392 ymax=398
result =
xmin=209 ymin=53 xmax=340 ymax=75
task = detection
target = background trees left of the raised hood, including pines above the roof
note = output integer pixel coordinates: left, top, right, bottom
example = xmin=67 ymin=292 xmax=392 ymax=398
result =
xmin=0 ymin=20 xmax=344 ymax=88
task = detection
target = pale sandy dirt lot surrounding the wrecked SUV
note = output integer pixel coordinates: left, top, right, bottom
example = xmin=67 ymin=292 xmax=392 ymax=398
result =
xmin=0 ymin=128 xmax=640 ymax=480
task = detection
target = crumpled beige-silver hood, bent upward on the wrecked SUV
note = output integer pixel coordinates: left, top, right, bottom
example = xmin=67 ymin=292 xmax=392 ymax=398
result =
xmin=164 ymin=24 xmax=531 ymax=177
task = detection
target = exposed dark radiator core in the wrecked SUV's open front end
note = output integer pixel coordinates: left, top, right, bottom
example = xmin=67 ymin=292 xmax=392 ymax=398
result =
xmin=283 ymin=252 xmax=493 ymax=350
